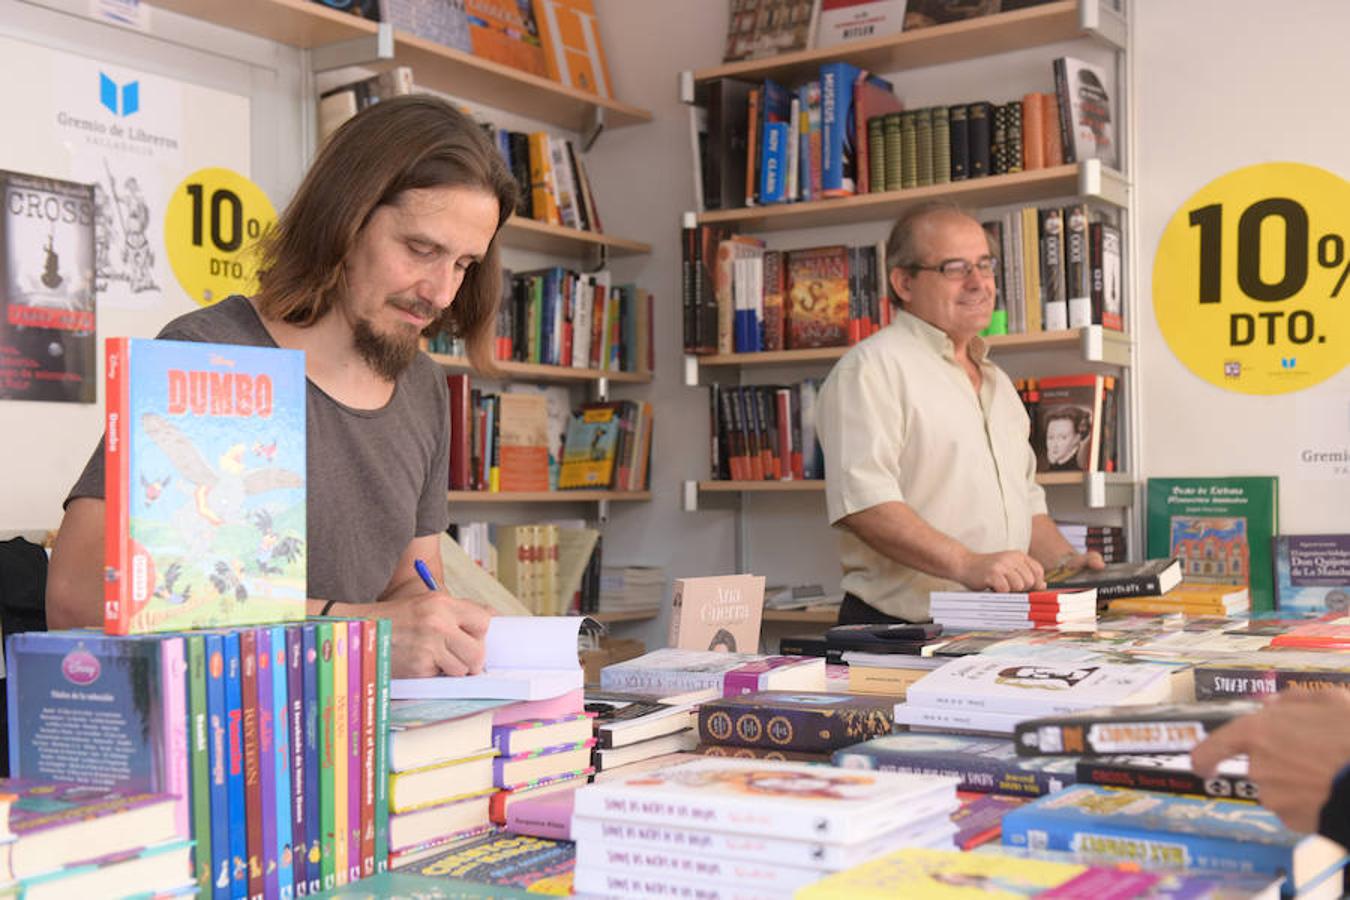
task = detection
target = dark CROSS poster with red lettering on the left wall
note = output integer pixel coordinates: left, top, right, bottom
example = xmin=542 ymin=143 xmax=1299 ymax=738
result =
xmin=0 ymin=170 xmax=97 ymax=403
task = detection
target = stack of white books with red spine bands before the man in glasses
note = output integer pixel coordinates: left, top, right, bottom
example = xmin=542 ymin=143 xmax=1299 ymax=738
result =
xmin=929 ymin=588 xmax=1098 ymax=631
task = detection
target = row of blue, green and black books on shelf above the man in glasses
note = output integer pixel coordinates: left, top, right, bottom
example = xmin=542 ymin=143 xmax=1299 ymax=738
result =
xmin=693 ymin=57 xmax=1119 ymax=209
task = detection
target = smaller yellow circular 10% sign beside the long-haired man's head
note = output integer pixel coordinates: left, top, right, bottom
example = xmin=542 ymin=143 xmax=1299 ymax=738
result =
xmin=165 ymin=169 xmax=277 ymax=306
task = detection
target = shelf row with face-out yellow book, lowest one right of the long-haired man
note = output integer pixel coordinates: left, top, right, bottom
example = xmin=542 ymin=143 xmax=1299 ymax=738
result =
xmin=447 ymin=374 xmax=653 ymax=493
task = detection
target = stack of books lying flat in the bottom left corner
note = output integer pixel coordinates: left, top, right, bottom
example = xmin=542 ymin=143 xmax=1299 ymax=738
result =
xmin=0 ymin=780 xmax=196 ymax=897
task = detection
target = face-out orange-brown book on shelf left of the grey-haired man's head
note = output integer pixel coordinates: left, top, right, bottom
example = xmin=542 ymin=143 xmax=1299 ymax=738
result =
xmin=786 ymin=246 xmax=849 ymax=349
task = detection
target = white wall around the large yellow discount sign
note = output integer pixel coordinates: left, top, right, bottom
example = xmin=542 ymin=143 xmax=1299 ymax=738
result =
xmin=1133 ymin=0 xmax=1350 ymax=533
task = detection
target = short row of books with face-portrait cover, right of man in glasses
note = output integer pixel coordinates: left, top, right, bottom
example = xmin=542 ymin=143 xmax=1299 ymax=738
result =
xmin=1017 ymin=372 xmax=1122 ymax=472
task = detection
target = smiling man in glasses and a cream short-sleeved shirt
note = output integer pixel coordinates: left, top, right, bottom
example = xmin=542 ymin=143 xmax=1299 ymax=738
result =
xmin=817 ymin=202 xmax=1103 ymax=625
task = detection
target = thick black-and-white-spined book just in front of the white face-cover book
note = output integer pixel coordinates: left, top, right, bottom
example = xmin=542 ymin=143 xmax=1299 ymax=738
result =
xmin=1014 ymin=700 xmax=1261 ymax=756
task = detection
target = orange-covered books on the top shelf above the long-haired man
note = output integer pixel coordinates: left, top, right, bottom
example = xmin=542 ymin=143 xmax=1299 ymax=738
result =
xmin=328 ymin=0 xmax=613 ymax=97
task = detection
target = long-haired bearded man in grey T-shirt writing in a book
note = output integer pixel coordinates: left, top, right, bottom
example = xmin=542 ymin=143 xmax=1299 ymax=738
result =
xmin=47 ymin=96 xmax=516 ymax=677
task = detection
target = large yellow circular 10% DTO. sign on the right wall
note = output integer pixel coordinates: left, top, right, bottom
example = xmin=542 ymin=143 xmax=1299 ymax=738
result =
xmin=1153 ymin=162 xmax=1350 ymax=394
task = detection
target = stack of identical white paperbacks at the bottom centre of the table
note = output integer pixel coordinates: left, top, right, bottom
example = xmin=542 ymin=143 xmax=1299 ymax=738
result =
xmin=572 ymin=758 xmax=957 ymax=897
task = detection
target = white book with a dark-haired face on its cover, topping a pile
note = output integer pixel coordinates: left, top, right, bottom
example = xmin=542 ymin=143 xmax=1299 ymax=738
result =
xmin=906 ymin=654 xmax=1176 ymax=715
